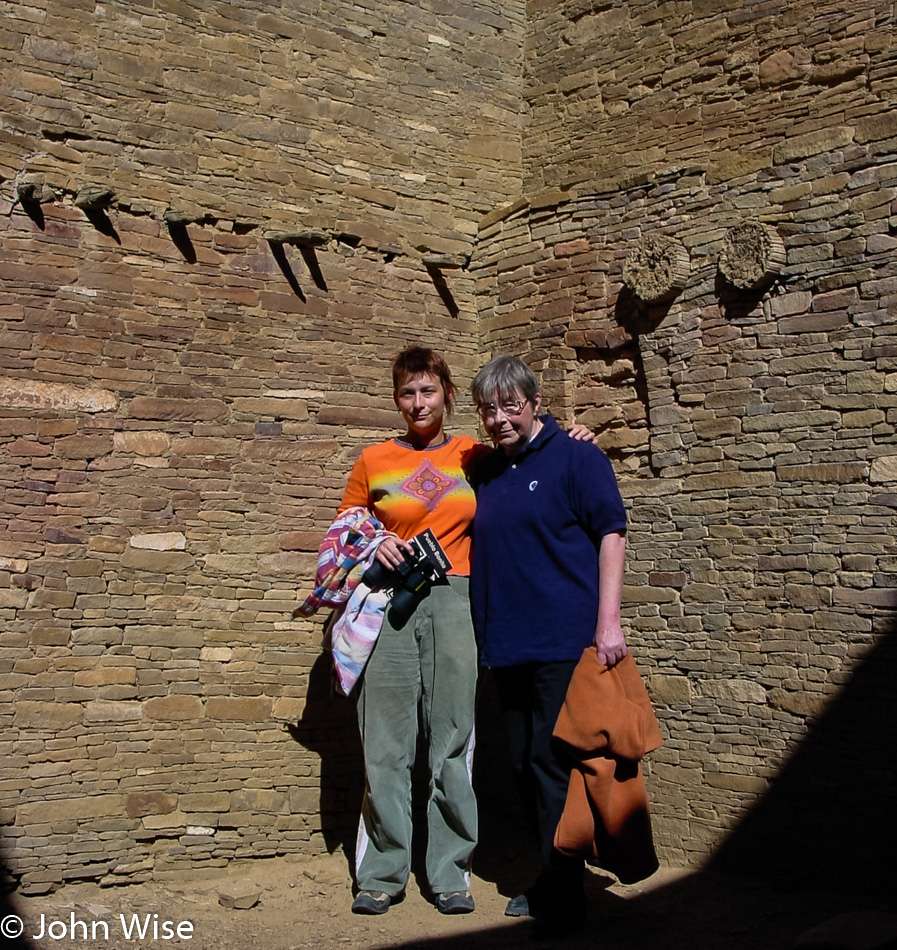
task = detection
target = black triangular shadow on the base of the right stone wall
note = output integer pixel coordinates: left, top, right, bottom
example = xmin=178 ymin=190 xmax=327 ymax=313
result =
xmin=709 ymin=623 xmax=897 ymax=891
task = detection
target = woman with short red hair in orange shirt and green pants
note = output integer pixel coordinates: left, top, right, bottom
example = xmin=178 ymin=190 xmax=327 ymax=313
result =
xmin=340 ymin=346 xmax=490 ymax=914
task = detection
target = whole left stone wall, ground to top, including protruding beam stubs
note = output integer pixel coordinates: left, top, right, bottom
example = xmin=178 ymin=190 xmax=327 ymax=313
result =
xmin=0 ymin=0 xmax=523 ymax=893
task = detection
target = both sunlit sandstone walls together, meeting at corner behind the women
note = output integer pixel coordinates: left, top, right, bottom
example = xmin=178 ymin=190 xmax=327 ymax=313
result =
xmin=0 ymin=0 xmax=897 ymax=893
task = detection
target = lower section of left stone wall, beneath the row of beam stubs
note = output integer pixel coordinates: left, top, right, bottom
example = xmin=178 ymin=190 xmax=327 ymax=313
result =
xmin=0 ymin=205 xmax=490 ymax=890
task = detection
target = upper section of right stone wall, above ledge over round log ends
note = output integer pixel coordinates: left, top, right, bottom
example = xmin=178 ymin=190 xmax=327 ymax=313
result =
xmin=524 ymin=0 xmax=897 ymax=195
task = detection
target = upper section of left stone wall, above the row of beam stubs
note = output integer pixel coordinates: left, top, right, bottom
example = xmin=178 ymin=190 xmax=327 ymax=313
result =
xmin=0 ymin=0 xmax=523 ymax=253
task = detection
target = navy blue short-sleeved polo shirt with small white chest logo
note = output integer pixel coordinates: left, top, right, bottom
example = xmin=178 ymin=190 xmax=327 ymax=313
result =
xmin=470 ymin=416 xmax=626 ymax=666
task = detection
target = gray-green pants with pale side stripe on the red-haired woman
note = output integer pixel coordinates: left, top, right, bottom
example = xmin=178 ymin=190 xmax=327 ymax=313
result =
xmin=355 ymin=576 xmax=477 ymax=897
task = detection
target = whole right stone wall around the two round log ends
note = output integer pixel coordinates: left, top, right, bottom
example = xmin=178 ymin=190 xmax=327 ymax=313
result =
xmin=472 ymin=3 xmax=897 ymax=873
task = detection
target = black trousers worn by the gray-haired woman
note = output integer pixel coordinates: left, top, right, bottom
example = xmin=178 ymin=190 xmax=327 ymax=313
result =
xmin=492 ymin=660 xmax=585 ymax=898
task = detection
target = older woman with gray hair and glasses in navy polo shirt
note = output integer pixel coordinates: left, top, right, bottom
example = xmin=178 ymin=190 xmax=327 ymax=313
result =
xmin=471 ymin=356 xmax=627 ymax=936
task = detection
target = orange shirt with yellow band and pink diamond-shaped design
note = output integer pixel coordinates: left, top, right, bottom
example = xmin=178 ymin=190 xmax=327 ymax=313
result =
xmin=339 ymin=435 xmax=492 ymax=575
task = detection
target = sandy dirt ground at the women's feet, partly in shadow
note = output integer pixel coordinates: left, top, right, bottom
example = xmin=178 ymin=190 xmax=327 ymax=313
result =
xmin=2 ymin=854 xmax=897 ymax=950
